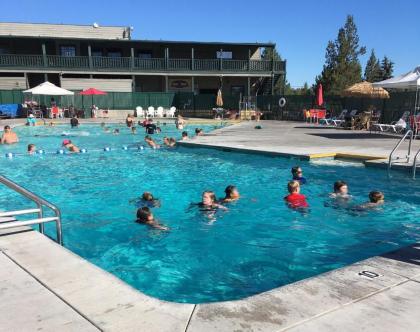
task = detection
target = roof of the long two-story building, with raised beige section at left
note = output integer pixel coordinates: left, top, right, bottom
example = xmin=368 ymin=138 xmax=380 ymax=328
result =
xmin=0 ymin=22 xmax=276 ymax=47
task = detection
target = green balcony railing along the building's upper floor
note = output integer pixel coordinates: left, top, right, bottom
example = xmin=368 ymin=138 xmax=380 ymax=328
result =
xmin=0 ymin=54 xmax=286 ymax=74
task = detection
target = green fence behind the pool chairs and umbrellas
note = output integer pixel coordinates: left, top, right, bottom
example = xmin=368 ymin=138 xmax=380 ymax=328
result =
xmin=0 ymin=90 xmax=415 ymax=122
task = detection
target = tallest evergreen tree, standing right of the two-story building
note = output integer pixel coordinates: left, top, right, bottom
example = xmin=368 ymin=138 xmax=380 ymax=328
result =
xmin=315 ymin=15 xmax=366 ymax=95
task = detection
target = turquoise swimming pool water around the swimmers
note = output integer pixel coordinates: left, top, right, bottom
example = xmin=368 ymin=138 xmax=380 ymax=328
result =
xmin=0 ymin=125 xmax=420 ymax=303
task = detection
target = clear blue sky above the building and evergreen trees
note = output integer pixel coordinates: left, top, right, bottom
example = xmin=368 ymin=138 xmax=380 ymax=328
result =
xmin=0 ymin=0 xmax=420 ymax=87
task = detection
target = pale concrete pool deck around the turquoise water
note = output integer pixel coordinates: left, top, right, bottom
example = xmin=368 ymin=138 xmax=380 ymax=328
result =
xmin=0 ymin=122 xmax=420 ymax=332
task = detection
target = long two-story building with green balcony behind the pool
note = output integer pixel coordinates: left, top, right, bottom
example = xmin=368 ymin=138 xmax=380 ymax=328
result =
xmin=0 ymin=23 xmax=286 ymax=95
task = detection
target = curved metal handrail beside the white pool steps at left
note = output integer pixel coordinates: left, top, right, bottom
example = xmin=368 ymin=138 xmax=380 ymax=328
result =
xmin=0 ymin=175 xmax=63 ymax=245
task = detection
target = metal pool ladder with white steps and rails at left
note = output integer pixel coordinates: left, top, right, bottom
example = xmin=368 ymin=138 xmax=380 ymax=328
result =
xmin=0 ymin=175 xmax=63 ymax=245
